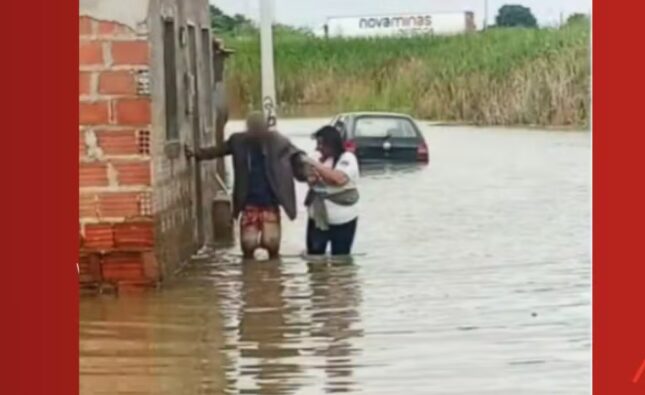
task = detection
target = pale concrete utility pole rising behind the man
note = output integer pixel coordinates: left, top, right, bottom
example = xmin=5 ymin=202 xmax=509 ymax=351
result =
xmin=258 ymin=0 xmax=277 ymax=126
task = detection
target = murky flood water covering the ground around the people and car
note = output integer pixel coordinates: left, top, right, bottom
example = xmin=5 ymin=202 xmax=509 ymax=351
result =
xmin=80 ymin=120 xmax=591 ymax=395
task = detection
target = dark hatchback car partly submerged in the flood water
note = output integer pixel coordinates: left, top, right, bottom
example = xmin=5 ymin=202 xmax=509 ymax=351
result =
xmin=331 ymin=112 xmax=430 ymax=163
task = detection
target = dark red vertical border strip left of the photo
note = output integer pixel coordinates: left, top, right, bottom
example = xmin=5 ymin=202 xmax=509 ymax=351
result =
xmin=0 ymin=0 xmax=78 ymax=395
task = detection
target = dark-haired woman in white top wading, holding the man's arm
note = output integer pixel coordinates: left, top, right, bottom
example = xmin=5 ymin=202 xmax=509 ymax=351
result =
xmin=305 ymin=126 xmax=359 ymax=256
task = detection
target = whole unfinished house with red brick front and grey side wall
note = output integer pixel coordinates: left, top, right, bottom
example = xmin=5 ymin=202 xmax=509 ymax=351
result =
xmin=79 ymin=0 xmax=226 ymax=286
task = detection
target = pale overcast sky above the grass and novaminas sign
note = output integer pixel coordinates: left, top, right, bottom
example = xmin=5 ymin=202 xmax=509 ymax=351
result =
xmin=211 ymin=0 xmax=591 ymax=29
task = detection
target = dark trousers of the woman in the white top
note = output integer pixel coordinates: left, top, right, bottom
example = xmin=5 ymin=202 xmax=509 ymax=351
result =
xmin=307 ymin=219 xmax=358 ymax=255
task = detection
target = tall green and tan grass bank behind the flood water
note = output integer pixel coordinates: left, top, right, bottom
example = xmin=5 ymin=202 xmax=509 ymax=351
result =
xmin=227 ymin=23 xmax=590 ymax=126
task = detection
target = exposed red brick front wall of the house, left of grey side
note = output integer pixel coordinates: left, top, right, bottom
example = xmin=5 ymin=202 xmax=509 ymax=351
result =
xmin=79 ymin=16 xmax=159 ymax=284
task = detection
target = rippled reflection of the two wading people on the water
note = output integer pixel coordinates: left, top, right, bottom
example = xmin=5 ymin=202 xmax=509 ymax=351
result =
xmin=213 ymin=261 xmax=362 ymax=394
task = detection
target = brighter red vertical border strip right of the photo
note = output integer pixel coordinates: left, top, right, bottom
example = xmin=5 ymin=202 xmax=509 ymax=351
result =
xmin=593 ymin=0 xmax=645 ymax=395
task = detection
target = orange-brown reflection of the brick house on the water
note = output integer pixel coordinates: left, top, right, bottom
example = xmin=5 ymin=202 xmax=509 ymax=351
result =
xmin=80 ymin=278 xmax=226 ymax=395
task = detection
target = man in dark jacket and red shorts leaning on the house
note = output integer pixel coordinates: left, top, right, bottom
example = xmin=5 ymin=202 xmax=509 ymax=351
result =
xmin=186 ymin=113 xmax=307 ymax=259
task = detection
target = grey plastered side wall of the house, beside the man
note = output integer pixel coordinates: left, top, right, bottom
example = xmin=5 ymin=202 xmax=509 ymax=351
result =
xmin=149 ymin=0 xmax=215 ymax=275
